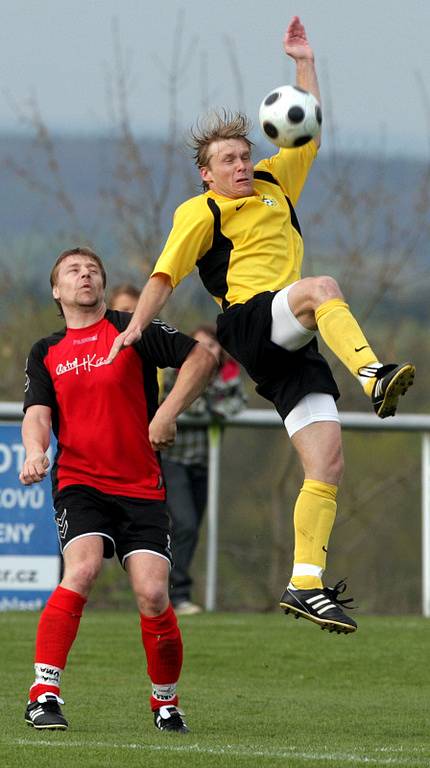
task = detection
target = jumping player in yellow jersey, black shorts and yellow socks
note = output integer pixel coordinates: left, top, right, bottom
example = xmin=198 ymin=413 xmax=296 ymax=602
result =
xmin=110 ymin=16 xmax=415 ymax=633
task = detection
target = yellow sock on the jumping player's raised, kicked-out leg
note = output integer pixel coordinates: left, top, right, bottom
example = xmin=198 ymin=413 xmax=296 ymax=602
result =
xmin=315 ymin=299 xmax=378 ymax=384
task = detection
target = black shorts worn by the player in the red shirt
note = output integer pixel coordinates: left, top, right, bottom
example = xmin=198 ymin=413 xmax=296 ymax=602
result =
xmin=54 ymin=485 xmax=172 ymax=565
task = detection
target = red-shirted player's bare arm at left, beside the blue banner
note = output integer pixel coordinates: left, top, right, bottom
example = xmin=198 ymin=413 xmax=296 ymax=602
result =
xmin=19 ymin=405 xmax=51 ymax=485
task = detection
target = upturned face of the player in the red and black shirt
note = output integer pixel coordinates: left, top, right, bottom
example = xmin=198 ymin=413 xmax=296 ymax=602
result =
xmin=52 ymin=254 xmax=104 ymax=311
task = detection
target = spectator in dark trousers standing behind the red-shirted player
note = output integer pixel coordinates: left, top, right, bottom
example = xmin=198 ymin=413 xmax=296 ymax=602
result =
xmin=163 ymin=324 xmax=246 ymax=615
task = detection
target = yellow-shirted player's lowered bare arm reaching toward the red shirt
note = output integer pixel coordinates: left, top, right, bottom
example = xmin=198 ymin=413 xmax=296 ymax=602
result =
xmin=106 ymin=272 xmax=172 ymax=363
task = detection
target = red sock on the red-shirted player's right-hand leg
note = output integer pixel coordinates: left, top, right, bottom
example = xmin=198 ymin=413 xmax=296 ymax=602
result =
xmin=140 ymin=605 xmax=182 ymax=709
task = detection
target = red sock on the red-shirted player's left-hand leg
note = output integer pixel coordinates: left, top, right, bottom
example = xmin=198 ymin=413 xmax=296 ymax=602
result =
xmin=30 ymin=587 xmax=87 ymax=701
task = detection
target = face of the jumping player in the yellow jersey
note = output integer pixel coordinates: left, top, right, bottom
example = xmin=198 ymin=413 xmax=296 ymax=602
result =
xmin=200 ymin=139 xmax=254 ymax=200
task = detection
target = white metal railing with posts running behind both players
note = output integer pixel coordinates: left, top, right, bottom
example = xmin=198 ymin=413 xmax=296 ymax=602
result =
xmin=0 ymin=402 xmax=430 ymax=617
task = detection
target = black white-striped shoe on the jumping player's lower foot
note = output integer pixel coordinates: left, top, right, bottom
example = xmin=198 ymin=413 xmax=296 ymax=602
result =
xmin=279 ymin=580 xmax=357 ymax=635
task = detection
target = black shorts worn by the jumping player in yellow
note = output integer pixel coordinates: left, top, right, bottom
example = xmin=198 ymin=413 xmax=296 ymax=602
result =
xmin=217 ymin=291 xmax=339 ymax=420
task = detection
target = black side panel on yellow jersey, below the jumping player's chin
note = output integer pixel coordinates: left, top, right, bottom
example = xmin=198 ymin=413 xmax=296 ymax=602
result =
xmin=197 ymin=197 xmax=233 ymax=309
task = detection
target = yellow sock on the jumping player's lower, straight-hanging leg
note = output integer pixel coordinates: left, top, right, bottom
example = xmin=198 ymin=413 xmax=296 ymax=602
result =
xmin=291 ymin=480 xmax=337 ymax=589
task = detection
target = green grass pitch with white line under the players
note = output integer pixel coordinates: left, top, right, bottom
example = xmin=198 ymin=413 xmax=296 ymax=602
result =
xmin=0 ymin=609 xmax=430 ymax=768
